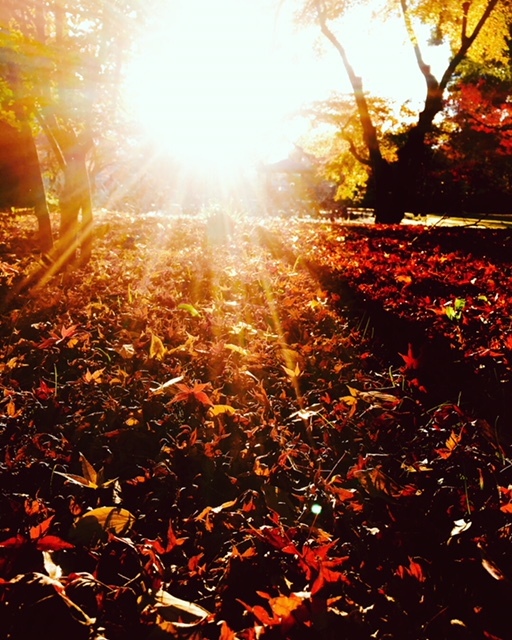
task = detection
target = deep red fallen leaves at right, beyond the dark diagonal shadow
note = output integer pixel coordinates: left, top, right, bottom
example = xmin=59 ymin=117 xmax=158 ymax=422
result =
xmin=290 ymin=224 xmax=512 ymax=380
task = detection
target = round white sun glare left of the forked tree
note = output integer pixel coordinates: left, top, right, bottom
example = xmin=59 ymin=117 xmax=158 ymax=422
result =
xmin=127 ymin=0 xmax=303 ymax=172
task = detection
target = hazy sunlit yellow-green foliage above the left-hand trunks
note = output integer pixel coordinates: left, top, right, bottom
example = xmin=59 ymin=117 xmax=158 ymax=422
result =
xmin=0 ymin=0 xmax=145 ymax=139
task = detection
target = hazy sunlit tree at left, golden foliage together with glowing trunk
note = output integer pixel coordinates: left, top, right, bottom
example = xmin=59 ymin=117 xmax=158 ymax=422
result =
xmin=0 ymin=0 xmax=143 ymax=260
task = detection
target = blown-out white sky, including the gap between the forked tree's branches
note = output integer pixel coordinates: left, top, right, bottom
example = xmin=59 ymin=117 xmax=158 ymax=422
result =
xmin=123 ymin=0 xmax=448 ymax=169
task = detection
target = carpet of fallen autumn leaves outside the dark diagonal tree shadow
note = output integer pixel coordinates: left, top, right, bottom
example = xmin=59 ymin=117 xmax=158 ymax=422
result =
xmin=0 ymin=212 xmax=512 ymax=640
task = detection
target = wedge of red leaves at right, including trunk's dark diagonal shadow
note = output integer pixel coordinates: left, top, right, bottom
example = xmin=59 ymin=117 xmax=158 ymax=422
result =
xmin=278 ymin=222 xmax=512 ymax=430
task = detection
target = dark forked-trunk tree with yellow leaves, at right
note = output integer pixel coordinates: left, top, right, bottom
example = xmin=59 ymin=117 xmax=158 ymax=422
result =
xmin=294 ymin=0 xmax=509 ymax=223
